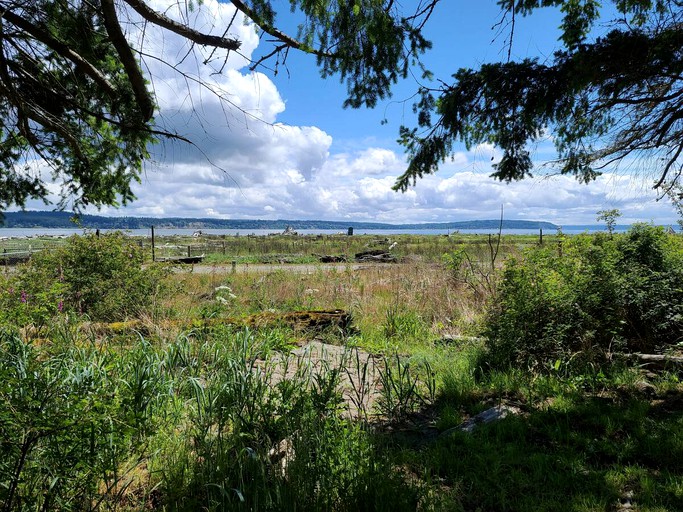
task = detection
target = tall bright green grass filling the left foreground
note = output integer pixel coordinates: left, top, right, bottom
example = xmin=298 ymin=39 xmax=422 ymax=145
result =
xmin=0 ymin=329 xmax=438 ymax=511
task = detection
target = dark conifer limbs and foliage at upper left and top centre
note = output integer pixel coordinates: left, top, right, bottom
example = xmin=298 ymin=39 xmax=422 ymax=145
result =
xmin=0 ymin=0 xmax=433 ymax=211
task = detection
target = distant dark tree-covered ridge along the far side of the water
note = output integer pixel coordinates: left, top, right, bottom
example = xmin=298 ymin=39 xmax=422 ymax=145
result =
xmin=0 ymin=211 xmax=558 ymax=232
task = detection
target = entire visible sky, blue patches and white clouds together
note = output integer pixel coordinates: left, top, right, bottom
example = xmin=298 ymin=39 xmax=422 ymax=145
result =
xmin=18 ymin=0 xmax=676 ymax=225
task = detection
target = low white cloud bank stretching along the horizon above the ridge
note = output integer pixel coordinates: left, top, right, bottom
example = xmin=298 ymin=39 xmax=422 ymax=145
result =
xmin=121 ymin=113 xmax=675 ymax=225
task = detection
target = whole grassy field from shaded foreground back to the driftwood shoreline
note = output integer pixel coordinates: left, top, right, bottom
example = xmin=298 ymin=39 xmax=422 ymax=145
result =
xmin=0 ymin=230 xmax=683 ymax=511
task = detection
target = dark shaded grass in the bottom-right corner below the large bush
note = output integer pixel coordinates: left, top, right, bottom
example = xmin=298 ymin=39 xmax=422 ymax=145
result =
xmin=384 ymin=391 xmax=683 ymax=511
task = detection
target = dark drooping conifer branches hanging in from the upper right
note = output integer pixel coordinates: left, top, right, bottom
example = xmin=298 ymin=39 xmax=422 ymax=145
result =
xmin=395 ymin=0 xmax=683 ymax=191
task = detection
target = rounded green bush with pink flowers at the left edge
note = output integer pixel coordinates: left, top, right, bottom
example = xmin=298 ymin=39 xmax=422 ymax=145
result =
xmin=0 ymin=233 xmax=167 ymax=325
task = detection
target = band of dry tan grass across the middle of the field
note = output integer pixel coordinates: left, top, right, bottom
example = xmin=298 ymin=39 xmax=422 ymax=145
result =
xmin=163 ymin=262 xmax=482 ymax=342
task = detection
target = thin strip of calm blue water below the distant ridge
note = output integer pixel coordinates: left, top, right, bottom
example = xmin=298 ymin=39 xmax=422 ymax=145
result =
xmin=0 ymin=225 xmax=648 ymax=239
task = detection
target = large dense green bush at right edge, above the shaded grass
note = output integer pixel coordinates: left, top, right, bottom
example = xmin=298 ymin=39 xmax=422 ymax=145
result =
xmin=485 ymin=224 xmax=683 ymax=369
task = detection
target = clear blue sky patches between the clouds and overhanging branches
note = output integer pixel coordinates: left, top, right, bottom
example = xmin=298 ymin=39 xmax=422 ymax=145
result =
xmin=271 ymin=0 xmax=561 ymax=151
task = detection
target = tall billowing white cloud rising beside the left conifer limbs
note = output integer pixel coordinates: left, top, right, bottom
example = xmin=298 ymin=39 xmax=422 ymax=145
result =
xmin=119 ymin=0 xmax=332 ymax=210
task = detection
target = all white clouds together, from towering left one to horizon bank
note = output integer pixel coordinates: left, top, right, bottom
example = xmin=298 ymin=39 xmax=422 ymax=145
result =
xmin=9 ymin=0 xmax=675 ymax=225
